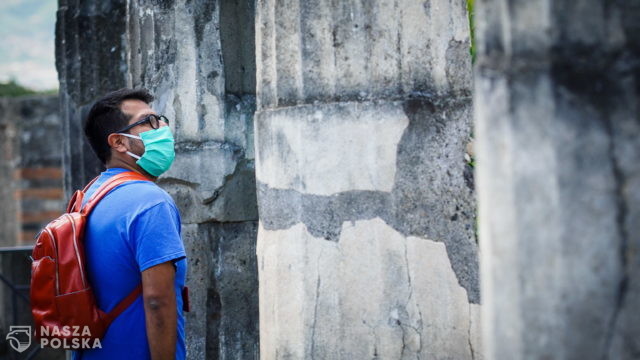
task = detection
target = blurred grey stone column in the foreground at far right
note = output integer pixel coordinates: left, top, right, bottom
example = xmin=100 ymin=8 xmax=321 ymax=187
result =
xmin=474 ymin=0 xmax=640 ymax=359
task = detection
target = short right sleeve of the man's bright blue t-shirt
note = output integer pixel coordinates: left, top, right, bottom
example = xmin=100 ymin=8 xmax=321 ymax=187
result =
xmin=131 ymin=201 xmax=186 ymax=272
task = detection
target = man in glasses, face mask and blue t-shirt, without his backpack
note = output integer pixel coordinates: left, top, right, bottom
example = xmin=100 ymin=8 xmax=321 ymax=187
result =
xmin=73 ymin=89 xmax=186 ymax=360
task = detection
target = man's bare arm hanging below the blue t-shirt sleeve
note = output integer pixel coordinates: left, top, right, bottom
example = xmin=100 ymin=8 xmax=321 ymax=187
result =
xmin=142 ymin=262 xmax=178 ymax=360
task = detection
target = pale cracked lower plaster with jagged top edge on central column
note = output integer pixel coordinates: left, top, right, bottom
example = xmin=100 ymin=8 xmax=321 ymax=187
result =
xmin=258 ymin=218 xmax=481 ymax=359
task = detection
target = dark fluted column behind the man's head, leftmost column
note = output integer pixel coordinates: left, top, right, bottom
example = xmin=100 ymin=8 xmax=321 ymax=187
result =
xmin=56 ymin=0 xmax=130 ymax=193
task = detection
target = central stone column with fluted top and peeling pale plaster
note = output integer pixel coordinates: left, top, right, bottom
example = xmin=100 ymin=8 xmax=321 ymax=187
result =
xmin=255 ymin=0 xmax=480 ymax=360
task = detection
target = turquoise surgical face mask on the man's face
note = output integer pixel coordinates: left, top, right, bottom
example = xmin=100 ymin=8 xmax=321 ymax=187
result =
xmin=118 ymin=126 xmax=176 ymax=176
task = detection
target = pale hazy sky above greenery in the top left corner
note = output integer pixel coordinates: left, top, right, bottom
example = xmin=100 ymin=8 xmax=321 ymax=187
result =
xmin=0 ymin=0 xmax=58 ymax=90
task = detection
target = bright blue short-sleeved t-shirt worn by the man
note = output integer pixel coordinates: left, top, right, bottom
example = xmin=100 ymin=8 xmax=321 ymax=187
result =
xmin=73 ymin=168 xmax=187 ymax=360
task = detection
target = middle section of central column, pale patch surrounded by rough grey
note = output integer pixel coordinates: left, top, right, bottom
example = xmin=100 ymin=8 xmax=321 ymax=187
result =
xmin=256 ymin=97 xmax=480 ymax=303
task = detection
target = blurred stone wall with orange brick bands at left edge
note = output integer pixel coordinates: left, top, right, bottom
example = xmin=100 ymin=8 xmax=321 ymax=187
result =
xmin=0 ymin=96 xmax=64 ymax=246
